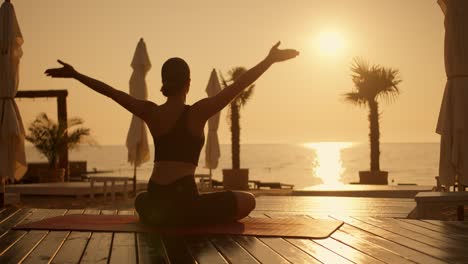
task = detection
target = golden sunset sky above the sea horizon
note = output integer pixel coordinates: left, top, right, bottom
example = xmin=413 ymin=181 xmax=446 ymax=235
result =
xmin=12 ymin=0 xmax=445 ymax=145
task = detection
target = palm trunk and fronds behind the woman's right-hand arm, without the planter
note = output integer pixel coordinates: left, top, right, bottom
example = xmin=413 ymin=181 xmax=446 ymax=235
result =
xmin=220 ymin=67 xmax=255 ymax=169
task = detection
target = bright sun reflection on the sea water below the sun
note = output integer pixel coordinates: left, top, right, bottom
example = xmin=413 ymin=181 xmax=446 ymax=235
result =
xmin=304 ymin=142 xmax=353 ymax=187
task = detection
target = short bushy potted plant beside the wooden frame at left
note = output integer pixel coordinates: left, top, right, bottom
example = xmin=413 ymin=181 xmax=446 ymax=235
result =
xmin=26 ymin=113 xmax=90 ymax=182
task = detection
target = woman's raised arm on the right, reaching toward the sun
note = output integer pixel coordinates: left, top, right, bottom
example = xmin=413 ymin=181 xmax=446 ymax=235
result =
xmin=194 ymin=42 xmax=299 ymax=121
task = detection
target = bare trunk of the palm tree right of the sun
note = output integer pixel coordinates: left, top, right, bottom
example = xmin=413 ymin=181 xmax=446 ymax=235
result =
xmin=369 ymin=100 xmax=380 ymax=171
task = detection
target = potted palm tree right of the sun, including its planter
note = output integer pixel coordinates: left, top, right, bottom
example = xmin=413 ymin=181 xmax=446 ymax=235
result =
xmin=344 ymin=58 xmax=402 ymax=184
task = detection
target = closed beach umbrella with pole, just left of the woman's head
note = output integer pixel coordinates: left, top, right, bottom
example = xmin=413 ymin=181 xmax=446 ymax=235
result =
xmin=126 ymin=39 xmax=151 ymax=193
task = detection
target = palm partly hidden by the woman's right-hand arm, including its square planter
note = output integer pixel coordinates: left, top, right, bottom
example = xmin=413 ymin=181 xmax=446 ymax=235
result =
xmin=220 ymin=67 xmax=255 ymax=190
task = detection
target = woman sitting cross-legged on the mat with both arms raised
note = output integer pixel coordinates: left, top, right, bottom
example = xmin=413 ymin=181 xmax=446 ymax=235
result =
xmin=45 ymin=42 xmax=299 ymax=225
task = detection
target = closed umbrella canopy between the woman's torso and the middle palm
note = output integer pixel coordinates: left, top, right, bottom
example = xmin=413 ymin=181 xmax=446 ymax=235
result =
xmin=205 ymin=69 xmax=221 ymax=171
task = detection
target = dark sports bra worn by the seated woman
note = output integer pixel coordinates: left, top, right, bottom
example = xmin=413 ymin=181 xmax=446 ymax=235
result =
xmin=154 ymin=105 xmax=205 ymax=165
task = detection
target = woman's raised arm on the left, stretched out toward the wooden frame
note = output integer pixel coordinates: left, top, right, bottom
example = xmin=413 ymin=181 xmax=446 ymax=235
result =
xmin=45 ymin=60 xmax=155 ymax=121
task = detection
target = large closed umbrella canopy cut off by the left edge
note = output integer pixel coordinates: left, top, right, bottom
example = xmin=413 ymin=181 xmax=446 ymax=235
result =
xmin=0 ymin=1 xmax=27 ymax=183
